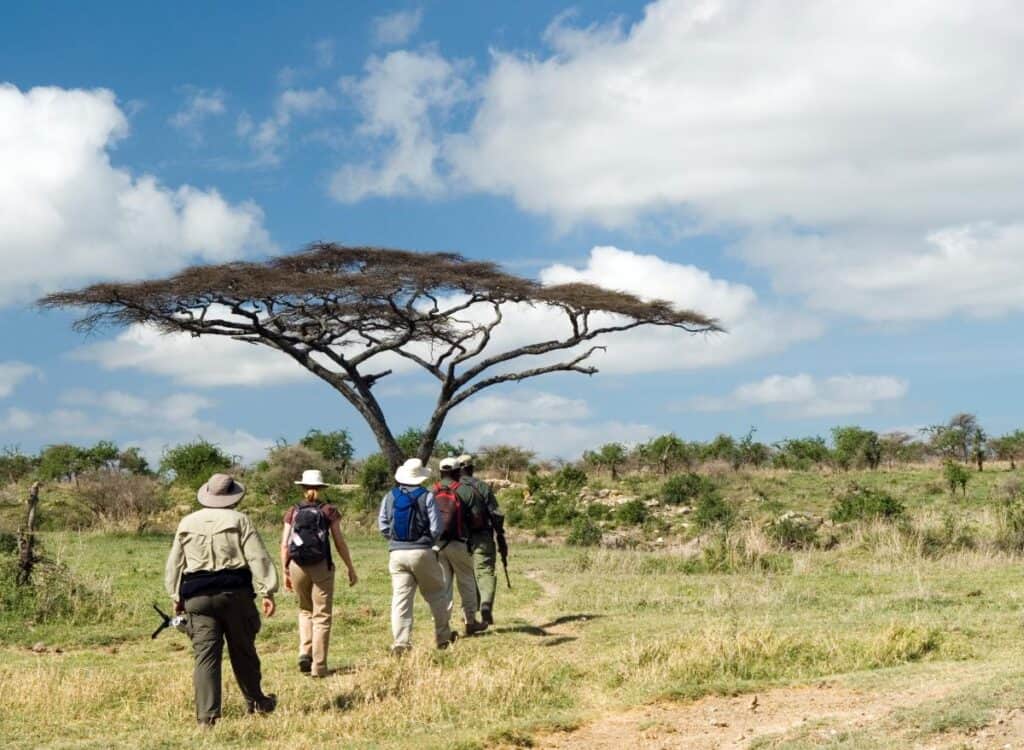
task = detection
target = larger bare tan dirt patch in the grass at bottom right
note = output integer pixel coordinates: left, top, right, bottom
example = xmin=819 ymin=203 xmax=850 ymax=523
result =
xmin=535 ymin=681 xmax=970 ymax=750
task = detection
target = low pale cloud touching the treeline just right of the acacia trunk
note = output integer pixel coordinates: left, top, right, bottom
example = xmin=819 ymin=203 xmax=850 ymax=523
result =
xmin=452 ymin=419 xmax=658 ymax=459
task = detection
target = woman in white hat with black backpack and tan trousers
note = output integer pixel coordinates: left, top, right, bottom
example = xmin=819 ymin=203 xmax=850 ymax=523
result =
xmin=281 ymin=469 xmax=358 ymax=677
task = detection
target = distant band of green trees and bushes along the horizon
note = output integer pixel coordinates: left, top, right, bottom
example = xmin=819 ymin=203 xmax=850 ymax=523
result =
xmin=6 ymin=414 xmax=1024 ymax=494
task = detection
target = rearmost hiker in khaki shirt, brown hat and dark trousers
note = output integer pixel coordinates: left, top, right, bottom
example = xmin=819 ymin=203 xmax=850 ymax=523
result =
xmin=164 ymin=474 xmax=278 ymax=726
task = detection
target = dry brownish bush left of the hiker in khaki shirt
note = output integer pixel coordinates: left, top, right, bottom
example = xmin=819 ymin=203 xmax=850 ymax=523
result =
xmin=78 ymin=469 xmax=167 ymax=532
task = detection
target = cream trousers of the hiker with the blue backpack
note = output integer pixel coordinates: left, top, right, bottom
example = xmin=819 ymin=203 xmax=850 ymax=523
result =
xmin=388 ymin=549 xmax=452 ymax=649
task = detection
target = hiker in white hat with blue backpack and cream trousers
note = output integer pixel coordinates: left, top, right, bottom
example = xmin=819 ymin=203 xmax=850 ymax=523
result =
xmin=377 ymin=458 xmax=456 ymax=656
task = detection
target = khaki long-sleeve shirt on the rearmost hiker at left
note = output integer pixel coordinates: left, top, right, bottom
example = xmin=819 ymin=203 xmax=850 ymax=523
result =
xmin=164 ymin=508 xmax=278 ymax=601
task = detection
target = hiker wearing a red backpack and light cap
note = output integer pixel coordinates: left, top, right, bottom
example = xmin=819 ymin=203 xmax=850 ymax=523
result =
xmin=433 ymin=457 xmax=487 ymax=635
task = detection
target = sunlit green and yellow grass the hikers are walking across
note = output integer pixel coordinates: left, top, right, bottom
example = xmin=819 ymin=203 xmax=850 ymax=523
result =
xmin=6 ymin=469 xmax=1024 ymax=748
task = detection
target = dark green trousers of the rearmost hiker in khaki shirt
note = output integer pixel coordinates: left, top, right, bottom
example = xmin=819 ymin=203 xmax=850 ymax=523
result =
xmin=185 ymin=591 xmax=264 ymax=721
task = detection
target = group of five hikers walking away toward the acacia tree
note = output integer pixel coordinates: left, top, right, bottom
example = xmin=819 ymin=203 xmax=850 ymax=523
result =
xmin=165 ymin=454 xmax=508 ymax=727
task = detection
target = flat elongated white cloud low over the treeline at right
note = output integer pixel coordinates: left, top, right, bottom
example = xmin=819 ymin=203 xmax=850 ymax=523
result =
xmin=685 ymin=374 xmax=909 ymax=418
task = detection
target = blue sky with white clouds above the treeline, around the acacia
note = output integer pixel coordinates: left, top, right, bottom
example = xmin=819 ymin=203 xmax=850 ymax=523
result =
xmin=0 ymin=0 xmax=1024 ymax=459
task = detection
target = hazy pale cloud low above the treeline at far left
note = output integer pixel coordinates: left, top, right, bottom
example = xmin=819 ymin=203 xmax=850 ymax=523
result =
xmin=0 ymin=388 xmax=273 ymax=462
